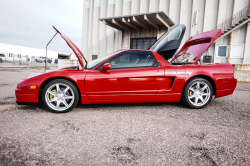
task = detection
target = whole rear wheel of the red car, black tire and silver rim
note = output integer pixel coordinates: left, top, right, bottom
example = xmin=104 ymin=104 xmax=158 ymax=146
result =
xmin=181 ymin=77 xmax=213 ymax=109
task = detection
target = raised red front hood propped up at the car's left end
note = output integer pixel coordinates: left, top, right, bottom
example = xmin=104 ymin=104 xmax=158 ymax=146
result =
xmin=53 ymin=26 xmax=88 ymax=69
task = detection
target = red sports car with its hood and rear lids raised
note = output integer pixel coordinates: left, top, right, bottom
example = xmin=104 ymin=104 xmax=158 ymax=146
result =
xmin=15 ymin=25 xmax=237 ymax=113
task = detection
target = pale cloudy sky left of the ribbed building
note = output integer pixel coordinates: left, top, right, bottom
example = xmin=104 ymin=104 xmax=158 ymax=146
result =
xmin=0 ymin=0 xmax=83 ymax=52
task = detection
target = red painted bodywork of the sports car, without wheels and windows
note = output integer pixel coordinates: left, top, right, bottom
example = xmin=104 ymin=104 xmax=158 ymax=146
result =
xmin=16 ymin=28 xmax=237 ymax=104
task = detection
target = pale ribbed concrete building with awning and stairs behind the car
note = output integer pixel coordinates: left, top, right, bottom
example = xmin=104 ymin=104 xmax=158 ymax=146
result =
xmin=82 ymin=0 xmax=250 ymax=64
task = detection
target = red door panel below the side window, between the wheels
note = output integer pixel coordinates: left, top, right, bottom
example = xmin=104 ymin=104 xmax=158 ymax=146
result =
xmin=85 ymin=67 xmax=164 ymax=100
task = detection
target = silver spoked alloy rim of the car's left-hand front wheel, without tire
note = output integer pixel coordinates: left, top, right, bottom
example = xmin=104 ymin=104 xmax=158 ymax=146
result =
xmin=45 ymin=83 xmax=75 ymax=111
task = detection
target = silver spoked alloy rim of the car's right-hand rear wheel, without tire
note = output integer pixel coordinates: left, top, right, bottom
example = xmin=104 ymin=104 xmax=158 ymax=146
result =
xmin=188 ymin=82 xmax=211 ymax=106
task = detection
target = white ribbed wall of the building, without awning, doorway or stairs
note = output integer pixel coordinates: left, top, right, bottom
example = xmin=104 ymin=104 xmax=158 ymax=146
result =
xmin=82 ymin=0 xmax=250 ymax=64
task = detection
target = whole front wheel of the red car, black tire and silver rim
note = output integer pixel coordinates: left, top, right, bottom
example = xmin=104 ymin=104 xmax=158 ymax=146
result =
xmin=42 ymin=79 xmax=79 ymax=113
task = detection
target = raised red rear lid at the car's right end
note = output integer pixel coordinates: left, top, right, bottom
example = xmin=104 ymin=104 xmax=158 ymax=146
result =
xmin=171 ymin=29 xmax=222 ymax=63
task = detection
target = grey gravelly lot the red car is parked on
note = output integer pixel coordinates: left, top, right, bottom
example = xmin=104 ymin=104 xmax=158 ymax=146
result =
xmin=0 ymin=69 xmax=250 ymax=166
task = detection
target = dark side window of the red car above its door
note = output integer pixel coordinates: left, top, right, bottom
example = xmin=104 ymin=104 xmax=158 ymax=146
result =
xmin=97 ymin=51 xmax=159 ymax=70
